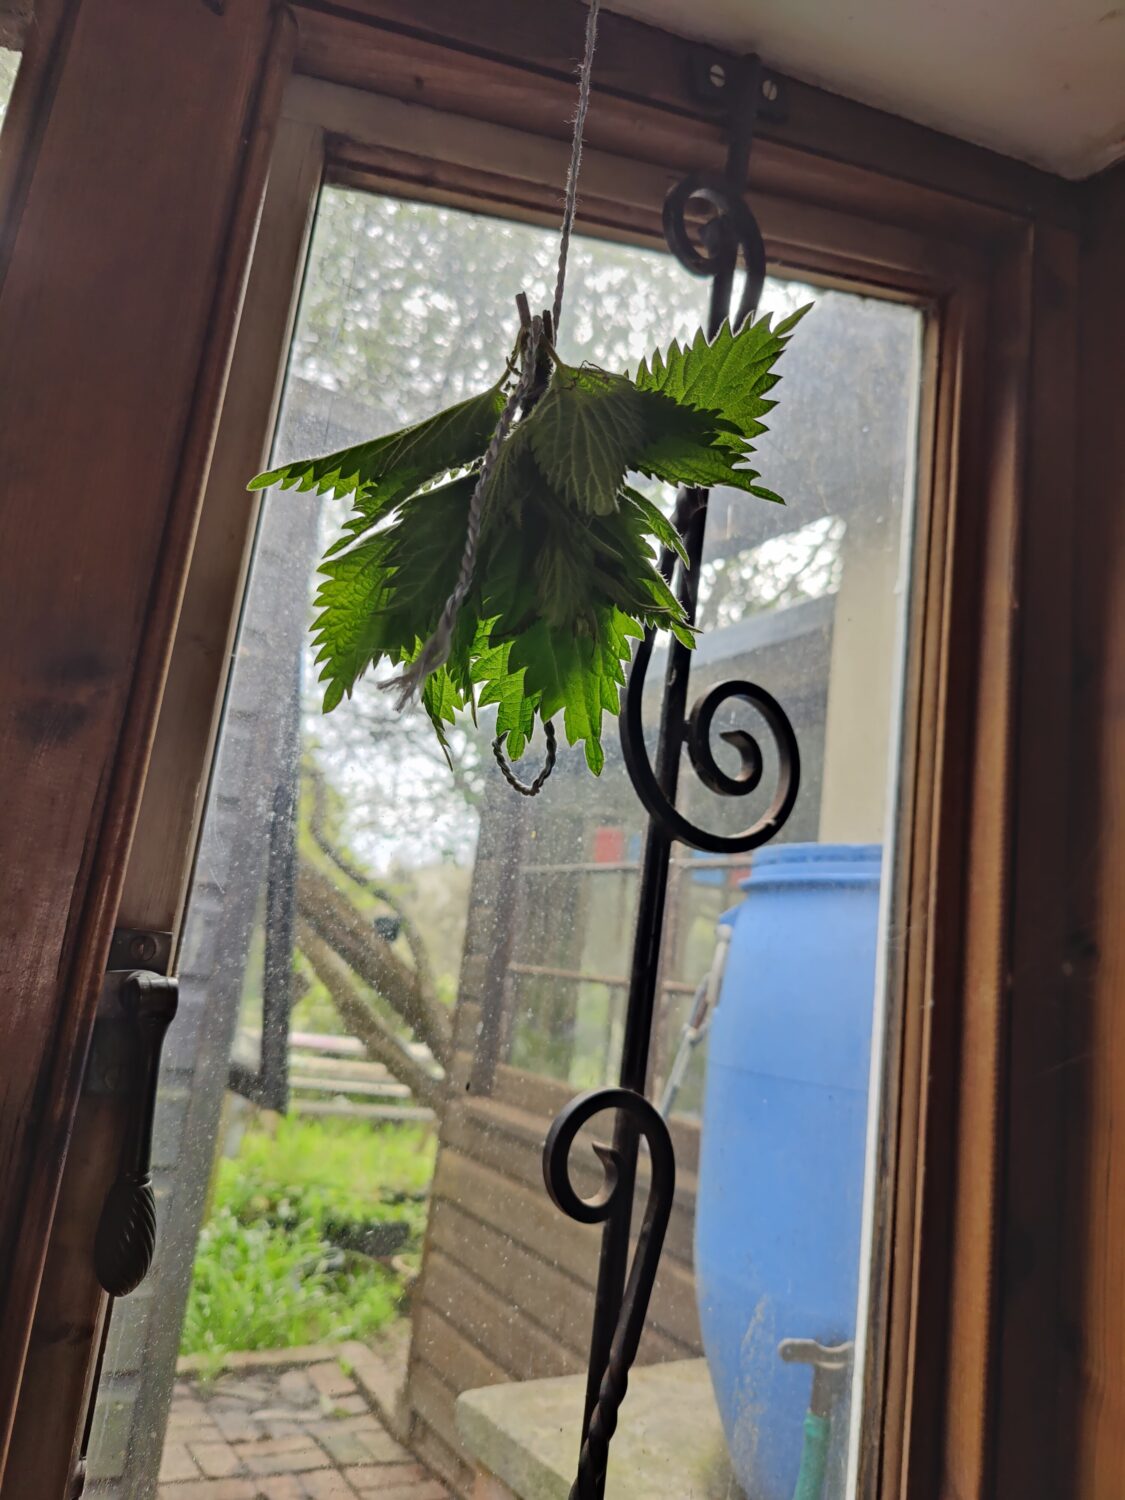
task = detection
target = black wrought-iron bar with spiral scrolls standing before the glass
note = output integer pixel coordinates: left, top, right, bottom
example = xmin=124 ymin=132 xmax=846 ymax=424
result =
xmin=543 ymin=46 xmax=801 ymax=1500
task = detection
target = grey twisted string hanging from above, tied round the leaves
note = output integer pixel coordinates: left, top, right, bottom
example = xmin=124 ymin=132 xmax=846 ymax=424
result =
xmin=380 ymin=0 xmax=602 ymax=726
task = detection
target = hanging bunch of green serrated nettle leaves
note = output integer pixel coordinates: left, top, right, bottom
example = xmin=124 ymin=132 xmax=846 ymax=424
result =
xmin=251 ymin=308 xmax=809 ymax=774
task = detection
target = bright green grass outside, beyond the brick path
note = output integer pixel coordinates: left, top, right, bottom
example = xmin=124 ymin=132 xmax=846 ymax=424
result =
xmin=180 ymin=1118 xmax=435 ymax=1367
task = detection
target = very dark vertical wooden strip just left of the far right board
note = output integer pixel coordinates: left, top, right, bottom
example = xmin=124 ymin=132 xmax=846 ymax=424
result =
xmin=990 ymin=225 xmax=1079 ymax=1500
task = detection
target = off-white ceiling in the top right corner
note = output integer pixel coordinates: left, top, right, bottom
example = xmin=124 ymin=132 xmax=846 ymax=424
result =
xmin=606 ymin=0 xmax=1125 ymax=177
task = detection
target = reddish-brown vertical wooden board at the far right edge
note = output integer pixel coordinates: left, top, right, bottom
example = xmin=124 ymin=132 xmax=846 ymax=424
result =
xmin=1059 ymin=168 xmax=1125 ymax=1500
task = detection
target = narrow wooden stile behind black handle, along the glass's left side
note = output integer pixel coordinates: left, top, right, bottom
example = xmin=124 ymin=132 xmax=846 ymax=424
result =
xmin=5 ymin=96 xmax=320 ymax=1496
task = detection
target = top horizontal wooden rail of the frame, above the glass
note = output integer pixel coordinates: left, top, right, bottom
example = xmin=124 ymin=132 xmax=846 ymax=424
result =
xmin=300 ymin=63 xmax=1022 ymax=261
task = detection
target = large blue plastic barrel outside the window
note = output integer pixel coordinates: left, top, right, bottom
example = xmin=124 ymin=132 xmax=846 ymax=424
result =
xmin=696 ymin=845 xmax=882 ymax=1500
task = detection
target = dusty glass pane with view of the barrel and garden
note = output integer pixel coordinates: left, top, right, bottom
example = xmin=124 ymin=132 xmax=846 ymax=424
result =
xmin=87 ymin=178 xmax=921 ymax=1500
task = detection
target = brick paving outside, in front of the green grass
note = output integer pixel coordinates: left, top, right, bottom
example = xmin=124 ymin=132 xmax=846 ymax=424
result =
xmin=159 ymin=1359 xmax=450 ymax=1500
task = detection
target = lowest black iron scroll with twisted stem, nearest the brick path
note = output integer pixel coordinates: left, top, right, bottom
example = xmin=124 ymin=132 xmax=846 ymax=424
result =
xmin=543 ymin=1089 xmax=677 ymax=1500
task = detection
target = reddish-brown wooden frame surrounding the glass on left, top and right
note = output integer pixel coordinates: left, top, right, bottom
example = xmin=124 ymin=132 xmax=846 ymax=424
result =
xmin=0 ymin=0 xmax=1080 ymax=1500
